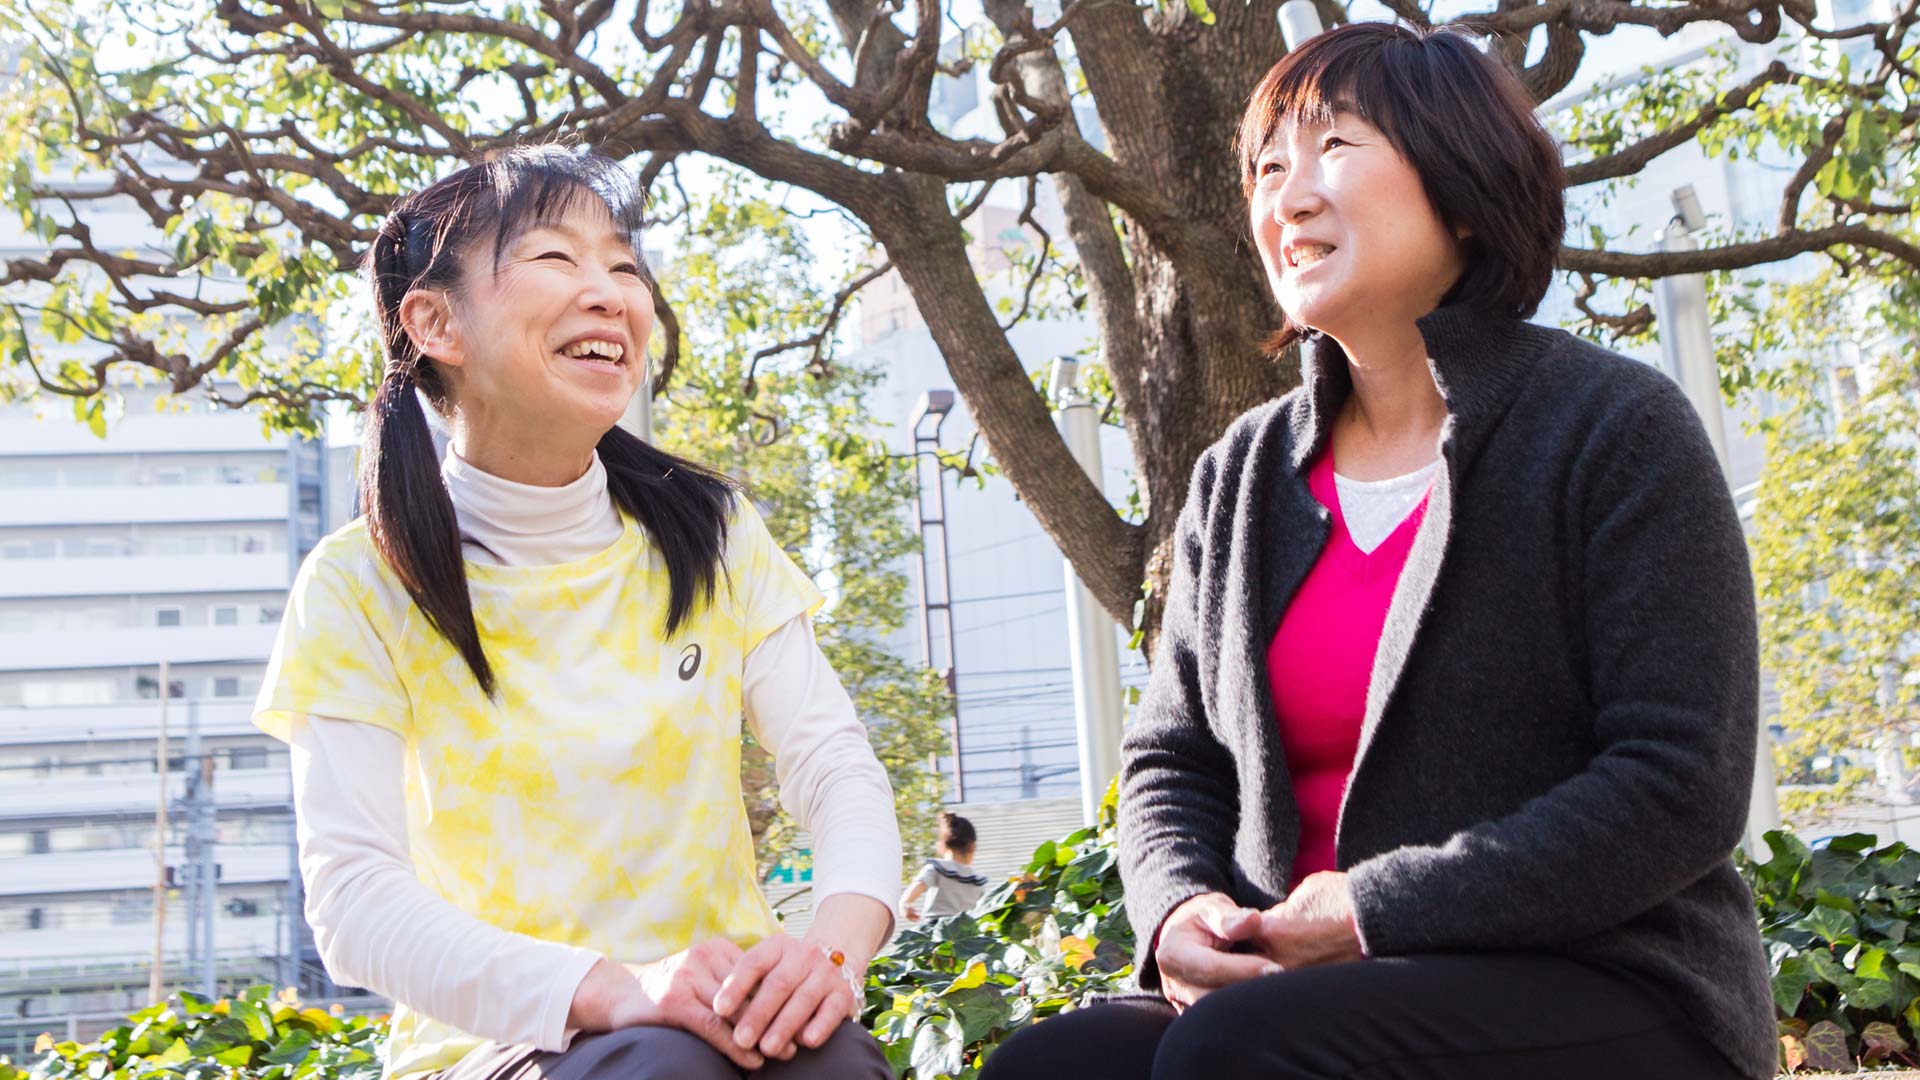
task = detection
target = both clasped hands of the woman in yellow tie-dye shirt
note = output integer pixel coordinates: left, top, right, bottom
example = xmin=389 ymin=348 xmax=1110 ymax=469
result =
xmin=568 ymin=934 xmax=858 ymax=1070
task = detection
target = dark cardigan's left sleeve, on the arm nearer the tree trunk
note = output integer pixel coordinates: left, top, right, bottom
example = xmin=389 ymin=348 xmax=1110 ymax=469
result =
xmin=1119 ymin=438 xmax=1240 ymax=990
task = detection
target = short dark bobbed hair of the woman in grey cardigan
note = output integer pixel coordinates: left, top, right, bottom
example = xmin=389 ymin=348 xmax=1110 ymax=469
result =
xmin=1235 ymin=23 xmax=1567 ymax=319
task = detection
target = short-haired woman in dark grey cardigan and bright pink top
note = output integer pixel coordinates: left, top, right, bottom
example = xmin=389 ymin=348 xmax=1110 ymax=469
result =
xmin=987 ymin=23 xmax=1776 ymax=1080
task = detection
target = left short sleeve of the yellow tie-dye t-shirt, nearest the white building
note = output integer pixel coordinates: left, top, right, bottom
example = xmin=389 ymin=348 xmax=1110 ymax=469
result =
xmin=253 ymin=544 xmax=411 ymax=742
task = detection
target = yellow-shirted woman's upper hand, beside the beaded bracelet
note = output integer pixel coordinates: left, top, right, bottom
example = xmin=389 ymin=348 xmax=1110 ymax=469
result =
xmin=714 ymin=930 xmax=860 ymax=1061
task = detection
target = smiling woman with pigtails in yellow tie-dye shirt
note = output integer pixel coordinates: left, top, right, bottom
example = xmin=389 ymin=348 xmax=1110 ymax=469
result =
xmin=253 ymin=146 xmax=900 ymax=1080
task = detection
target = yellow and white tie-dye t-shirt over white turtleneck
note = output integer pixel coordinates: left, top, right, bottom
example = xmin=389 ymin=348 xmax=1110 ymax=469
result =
xmin=253 ymin=502 xmax=822 ymax=1078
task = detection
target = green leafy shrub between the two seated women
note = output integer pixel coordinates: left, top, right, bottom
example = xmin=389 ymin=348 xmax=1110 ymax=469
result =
xmin=862 ymin=776 xmax=1133 ymax=1080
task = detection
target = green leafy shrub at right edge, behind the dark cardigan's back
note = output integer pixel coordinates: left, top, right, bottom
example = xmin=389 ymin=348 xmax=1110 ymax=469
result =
xmin=1740 ymin=832 xmax=1920 ymax=1070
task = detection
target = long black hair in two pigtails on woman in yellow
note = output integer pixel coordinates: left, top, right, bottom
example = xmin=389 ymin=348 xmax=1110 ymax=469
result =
xmin=361 ymin=146 xmax=737 ymax=698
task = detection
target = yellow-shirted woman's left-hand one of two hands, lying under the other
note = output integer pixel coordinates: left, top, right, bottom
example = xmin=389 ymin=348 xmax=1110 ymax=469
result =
xmin=566 ymin=938 xmax=766 ymax=1070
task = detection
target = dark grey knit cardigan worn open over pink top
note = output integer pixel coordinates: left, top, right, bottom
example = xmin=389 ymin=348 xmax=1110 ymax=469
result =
xmin=1119 ymin=307 xmax=1776 ymax=1078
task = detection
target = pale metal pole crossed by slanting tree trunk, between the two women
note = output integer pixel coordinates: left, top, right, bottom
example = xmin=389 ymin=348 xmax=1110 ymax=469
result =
xmin=1052 ymin=356 xmax=1125 ymax=824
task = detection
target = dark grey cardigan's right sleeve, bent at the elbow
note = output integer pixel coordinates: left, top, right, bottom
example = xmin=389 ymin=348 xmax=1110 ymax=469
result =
xmin=1350 ymin=380 xmax=1759 ymax=955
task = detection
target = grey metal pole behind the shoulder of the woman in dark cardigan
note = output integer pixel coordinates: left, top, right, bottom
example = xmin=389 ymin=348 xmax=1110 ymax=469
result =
xmin=1653 ymin=184 xmax=1780 ymax=859
